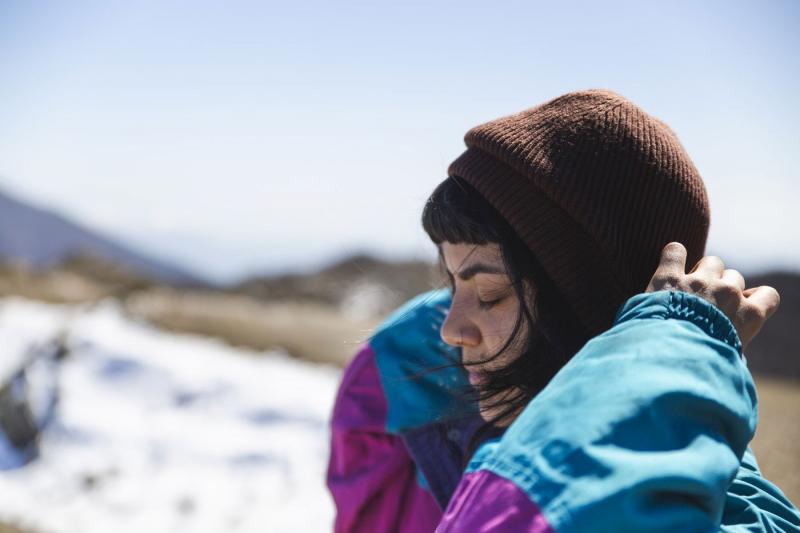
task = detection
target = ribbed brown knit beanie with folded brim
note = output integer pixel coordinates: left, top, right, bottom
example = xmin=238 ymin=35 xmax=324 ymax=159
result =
xmin=448 ymin=89 xmax=710 ymax=335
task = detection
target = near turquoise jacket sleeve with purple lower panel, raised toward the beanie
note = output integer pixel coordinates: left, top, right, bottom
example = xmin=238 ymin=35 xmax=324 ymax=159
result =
xmin=437 ymin=291 xmax=756 ymax=532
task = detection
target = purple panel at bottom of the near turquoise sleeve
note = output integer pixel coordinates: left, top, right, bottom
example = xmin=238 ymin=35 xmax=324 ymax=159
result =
xmin=436 ymin=470 xmax=553 ymax=533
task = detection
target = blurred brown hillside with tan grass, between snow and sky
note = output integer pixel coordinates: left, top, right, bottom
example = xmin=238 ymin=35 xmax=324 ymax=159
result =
xmin=0 ymin=254 xmax=436 ymax=366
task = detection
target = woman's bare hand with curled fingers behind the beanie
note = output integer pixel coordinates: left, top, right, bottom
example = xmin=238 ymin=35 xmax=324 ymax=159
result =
xmin=645 ymin=242 xmax=781 ymax=350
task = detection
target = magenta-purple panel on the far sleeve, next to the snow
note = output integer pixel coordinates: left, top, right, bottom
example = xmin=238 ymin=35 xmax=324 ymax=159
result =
xmin=327 ymin=345 xmax=442 ymax=533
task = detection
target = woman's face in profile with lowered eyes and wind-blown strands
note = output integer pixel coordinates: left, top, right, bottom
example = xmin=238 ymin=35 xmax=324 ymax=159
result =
xmin=441 ymin=242 xmax=528 ymax=420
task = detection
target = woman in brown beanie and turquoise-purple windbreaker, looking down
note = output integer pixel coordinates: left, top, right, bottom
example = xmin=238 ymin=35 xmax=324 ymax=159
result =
xmin=328 ymin=90 xmax=800 ymax=531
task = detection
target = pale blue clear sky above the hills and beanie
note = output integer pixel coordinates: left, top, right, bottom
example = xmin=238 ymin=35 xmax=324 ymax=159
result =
xmin=0 ymin=0 xmax=800 ymax=279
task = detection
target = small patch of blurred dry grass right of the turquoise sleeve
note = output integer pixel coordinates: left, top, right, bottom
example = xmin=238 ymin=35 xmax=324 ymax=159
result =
xmin=752 ymin=376 xmax=800 ymax=505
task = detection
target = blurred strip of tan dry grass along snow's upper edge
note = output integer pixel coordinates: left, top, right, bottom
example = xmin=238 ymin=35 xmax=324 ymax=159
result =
xmin=0 ymin=264 xmax=379 ymax=366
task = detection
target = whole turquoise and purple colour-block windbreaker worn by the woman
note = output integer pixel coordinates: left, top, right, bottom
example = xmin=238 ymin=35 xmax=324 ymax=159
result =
xmin=327 ymin=290 xmax=800 ymax=532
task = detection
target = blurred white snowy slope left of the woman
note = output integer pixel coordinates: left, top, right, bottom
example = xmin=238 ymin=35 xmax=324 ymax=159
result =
xmin=0 ymin=300 xmax=339 ymax=533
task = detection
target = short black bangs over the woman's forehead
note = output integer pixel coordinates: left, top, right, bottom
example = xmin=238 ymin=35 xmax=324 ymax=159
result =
xmin=422 ymin=176 xmax=507 ymax=244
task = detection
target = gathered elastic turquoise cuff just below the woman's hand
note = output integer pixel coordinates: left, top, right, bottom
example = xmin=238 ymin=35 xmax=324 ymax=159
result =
xmin=614 ymin=290 xmax=744 ymax=357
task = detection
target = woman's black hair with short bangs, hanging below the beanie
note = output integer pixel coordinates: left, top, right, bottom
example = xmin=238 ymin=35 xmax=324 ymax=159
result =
xmin=422 ymin=177 xmax=589 ymax=454
